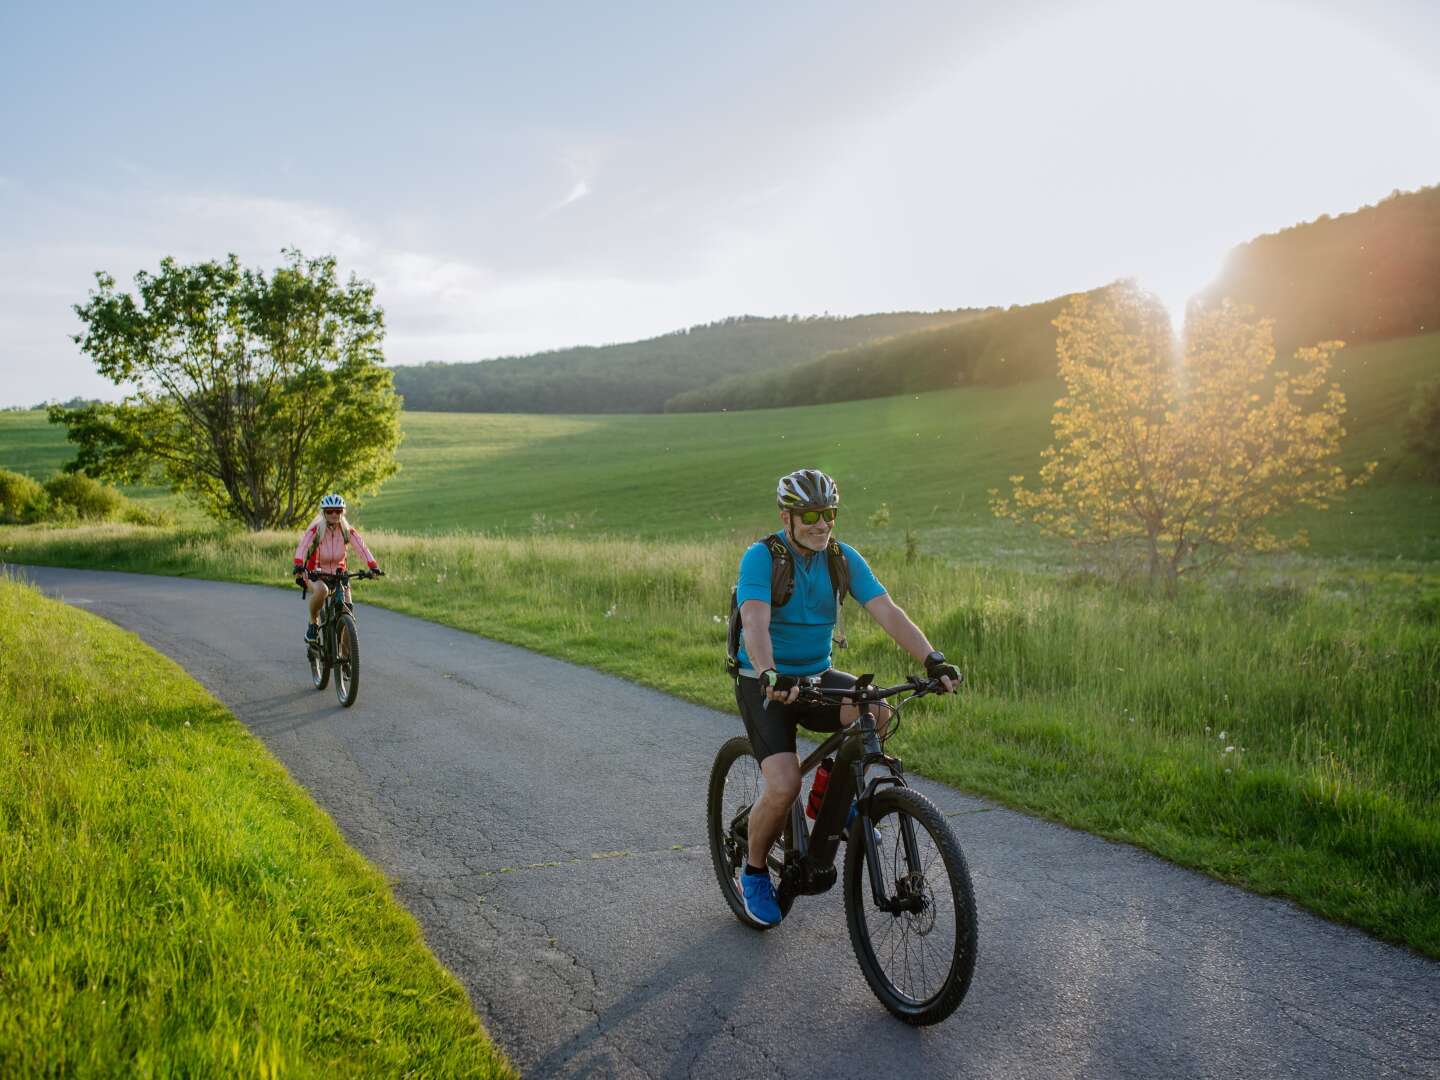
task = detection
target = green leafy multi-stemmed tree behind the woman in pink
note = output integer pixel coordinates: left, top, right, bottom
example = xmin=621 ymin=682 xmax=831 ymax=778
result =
xmin=50 ymin=251 xmax=400 ymax=530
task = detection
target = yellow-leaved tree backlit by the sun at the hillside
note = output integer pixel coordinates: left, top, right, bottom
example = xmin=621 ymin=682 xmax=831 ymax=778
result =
xmin=991 ymin=282 xmax=1374 ymax=586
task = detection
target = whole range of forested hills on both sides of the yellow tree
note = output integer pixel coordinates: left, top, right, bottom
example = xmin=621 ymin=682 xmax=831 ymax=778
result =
xmin=395 ymin=187 xmax=1440 ymax=413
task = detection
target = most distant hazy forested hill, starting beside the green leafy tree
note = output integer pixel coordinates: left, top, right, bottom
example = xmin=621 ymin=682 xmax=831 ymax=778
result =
xmin=393 ymin=315 xmax=984 ymax=413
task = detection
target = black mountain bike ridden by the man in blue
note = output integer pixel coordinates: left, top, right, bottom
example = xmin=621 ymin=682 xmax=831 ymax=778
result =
xmin=707 ymin=675 xmax=978 ymax=1025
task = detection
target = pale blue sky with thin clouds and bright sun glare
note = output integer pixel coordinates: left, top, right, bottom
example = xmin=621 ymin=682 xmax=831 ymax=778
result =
xmin=0 ymin=0 xmax=1440 ymax=406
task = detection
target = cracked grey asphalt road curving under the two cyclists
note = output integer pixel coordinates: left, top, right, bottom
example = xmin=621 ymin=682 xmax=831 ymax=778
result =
xmin=17 ymin=567 xmax=1440 ymax=1080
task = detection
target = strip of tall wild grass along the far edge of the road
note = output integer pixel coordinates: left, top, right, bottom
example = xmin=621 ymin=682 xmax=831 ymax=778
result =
xmin=0 ymin=526 xmax=1440 ymax=958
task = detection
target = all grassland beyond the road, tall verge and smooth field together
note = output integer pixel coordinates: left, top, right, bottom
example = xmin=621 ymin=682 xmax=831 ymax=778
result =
xmin=0 ymin=334 xmax=1440 ymax=956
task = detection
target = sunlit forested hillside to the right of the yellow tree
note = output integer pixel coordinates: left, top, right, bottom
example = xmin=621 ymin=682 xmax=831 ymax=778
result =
xmin=1201 ymin=187 xmax=1440 ymax=351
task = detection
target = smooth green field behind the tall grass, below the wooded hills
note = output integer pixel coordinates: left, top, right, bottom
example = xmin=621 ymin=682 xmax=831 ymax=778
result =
xmin=0 ymin=334 xmax=1440 ymax=566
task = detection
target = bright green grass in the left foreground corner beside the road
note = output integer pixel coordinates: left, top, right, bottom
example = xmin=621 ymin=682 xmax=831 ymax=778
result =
xmin=0 ymin=579 xmax=514 ymax=1077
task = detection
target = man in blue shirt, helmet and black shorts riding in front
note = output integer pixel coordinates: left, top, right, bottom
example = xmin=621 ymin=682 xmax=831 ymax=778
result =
xmin=734 ymin=469 xmax=960 ymax=926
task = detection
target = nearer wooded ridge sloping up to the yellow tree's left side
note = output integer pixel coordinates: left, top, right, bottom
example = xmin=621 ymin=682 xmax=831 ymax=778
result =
xmin=665 ymin=289 xmax=1088 ymax=412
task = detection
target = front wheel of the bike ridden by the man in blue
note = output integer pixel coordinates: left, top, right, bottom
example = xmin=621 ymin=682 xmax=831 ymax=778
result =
xmin=845 ymin=788 xmax=978 ymax=1025
